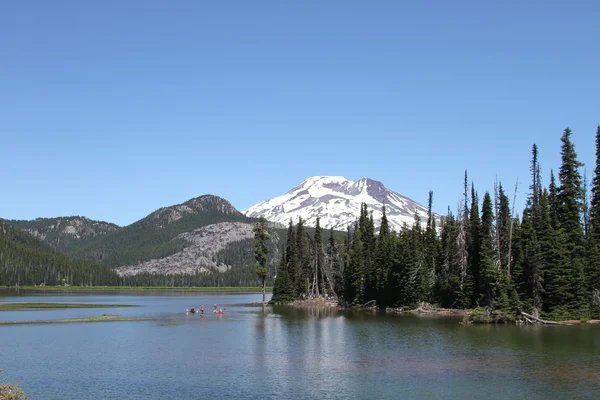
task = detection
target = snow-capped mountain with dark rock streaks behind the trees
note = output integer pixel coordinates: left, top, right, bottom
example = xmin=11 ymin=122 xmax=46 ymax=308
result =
xmin=243 ymin=176 xmax=439 ymax=231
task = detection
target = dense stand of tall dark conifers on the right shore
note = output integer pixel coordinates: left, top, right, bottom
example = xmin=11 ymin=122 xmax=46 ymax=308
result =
xmin=272 ymin=126 xmax=600 ymax=319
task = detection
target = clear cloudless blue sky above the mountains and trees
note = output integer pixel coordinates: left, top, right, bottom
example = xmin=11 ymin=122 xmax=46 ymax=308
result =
xmin=0 ymin=0 xmax=600 ymax=225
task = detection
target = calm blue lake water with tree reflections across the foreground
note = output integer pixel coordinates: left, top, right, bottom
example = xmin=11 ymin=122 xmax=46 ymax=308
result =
xmin=0 ymin=292 xmax=600 ymax=400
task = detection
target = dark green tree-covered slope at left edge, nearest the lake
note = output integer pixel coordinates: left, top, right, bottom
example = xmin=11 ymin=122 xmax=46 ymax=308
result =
xmin=0 ymin=220 xmax=120 ymax=286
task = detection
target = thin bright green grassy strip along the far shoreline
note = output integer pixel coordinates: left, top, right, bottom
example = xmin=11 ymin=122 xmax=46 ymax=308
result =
xmin=0 ymin=286 xmax=273 ymax=293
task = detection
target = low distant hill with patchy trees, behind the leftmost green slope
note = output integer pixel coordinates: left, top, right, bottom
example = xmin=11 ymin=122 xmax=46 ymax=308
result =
xmin=8 ymin=216 xmax=119 ymax=254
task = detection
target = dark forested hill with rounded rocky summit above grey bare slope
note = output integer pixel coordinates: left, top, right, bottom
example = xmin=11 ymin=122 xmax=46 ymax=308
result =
xmin=71 ymin=195 xmax=255 ymax=267
